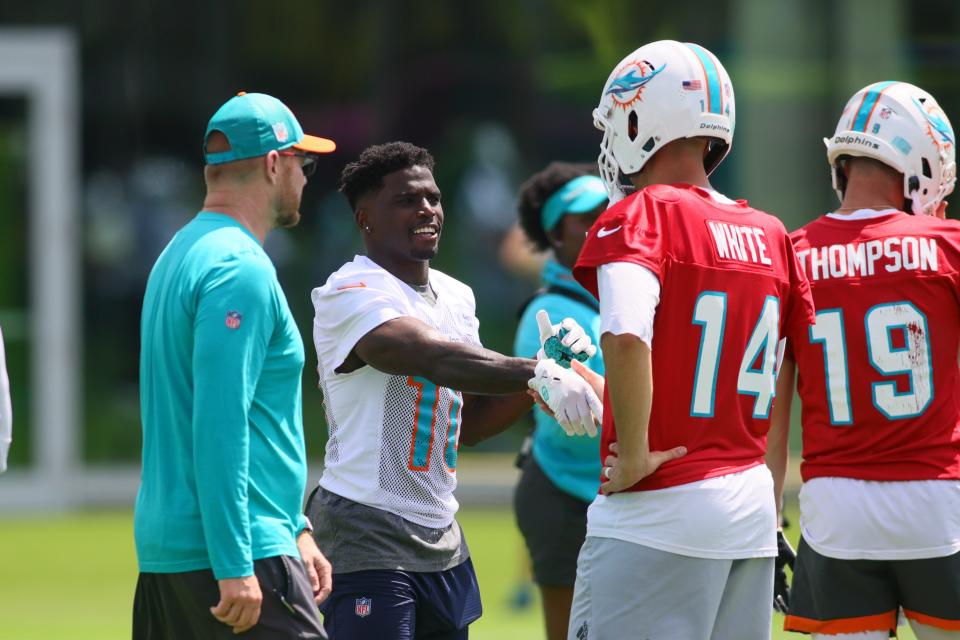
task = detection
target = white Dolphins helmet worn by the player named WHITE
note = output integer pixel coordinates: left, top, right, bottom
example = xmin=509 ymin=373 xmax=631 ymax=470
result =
xmin=593 ymin=40 xmax=735 ymax=204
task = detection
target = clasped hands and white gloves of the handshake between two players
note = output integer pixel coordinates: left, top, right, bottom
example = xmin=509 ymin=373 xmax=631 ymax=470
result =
xmin=527 ymin=309 xmax=603 ymax=438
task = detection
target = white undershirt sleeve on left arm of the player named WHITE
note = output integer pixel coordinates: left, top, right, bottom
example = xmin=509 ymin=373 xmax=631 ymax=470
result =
xmin=597 ymin=262 xmax=660 ymax=350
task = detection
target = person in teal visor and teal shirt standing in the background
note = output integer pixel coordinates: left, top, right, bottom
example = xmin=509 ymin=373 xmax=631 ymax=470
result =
xmin=514 ymin=162 xmax=607 ymax=640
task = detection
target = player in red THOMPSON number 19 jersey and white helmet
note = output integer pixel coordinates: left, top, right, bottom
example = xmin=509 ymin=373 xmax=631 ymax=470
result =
xmin=771 ymin=82 xmax=960 ymax=640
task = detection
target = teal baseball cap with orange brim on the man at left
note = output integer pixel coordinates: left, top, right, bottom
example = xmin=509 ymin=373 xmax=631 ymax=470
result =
xmin=203 ymin=91 xmax=337 ymax=164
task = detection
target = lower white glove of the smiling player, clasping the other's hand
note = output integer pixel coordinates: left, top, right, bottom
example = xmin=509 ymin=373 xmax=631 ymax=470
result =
xmin=527 ymin=358 xmax=603 ymax=438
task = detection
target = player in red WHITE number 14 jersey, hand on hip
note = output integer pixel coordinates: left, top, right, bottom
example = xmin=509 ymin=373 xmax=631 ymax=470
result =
xmin=569 ymin=41 xmax=813 ymax=640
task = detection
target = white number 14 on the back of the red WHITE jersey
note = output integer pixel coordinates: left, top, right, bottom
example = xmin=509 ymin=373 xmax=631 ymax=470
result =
xmin=690 ymin=291 xmax=780 ymax=419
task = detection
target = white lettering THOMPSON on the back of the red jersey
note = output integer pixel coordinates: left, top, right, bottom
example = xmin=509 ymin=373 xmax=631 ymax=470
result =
xmin=797 ymin=236 xmax=937 ymax=280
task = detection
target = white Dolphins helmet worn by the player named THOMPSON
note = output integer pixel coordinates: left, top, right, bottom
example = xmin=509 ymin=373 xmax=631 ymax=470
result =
xmin=823 ymin=81 xmax=957 ymax=215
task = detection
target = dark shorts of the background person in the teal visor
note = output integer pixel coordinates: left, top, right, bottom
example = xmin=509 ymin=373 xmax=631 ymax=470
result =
xmin=513 ymin=456 xmax=590 ymax=587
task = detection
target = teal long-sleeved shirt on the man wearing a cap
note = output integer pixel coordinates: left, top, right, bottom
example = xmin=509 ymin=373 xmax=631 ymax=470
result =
xmin=134 ymin=212 xmax=306 ymax=579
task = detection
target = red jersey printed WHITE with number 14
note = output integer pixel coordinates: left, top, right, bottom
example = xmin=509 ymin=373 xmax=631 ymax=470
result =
xmin=574 ymin=185 xmax=814 ymax=491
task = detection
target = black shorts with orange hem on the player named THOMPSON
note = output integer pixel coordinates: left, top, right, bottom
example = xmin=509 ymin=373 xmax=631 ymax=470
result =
xmin=784 ymin=538 xmax=960 ymax=634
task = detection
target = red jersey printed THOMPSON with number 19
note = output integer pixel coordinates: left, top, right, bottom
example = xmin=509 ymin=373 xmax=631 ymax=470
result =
xmin=791 ymin=212 xmax=960 ymax=480
